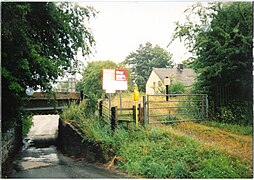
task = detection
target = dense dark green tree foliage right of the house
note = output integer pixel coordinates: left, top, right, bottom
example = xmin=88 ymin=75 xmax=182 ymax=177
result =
xmin=173 ymin=2 xmax=253 ymax=121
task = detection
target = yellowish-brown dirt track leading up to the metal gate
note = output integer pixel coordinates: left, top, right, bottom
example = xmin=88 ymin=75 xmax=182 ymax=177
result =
xmin=152 ymin=122 xmax=253 ymax=165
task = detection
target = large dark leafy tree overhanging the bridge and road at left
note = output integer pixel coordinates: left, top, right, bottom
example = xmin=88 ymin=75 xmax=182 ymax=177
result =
xmin=1 ymin=2 xmax=96 ymax=129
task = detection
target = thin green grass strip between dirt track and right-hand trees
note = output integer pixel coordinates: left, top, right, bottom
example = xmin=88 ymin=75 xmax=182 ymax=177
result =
xmin=199 ymin=121 xmax=253 ymax=136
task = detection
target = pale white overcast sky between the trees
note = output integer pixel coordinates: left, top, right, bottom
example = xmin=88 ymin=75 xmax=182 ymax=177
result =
xmin=79 ymin=1 xmax=194 ymax=63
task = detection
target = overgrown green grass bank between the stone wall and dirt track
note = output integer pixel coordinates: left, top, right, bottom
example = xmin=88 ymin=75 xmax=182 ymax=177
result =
xmin=62 ymin=102 xmax=252 ymax=178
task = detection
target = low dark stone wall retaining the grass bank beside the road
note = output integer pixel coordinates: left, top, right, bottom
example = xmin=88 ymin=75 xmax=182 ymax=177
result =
xmin=58 ymin=119 xmax=113 ymax=163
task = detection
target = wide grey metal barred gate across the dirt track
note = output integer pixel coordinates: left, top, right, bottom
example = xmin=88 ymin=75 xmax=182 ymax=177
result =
xmin=143 ymin=94 xmax=208 ymax=124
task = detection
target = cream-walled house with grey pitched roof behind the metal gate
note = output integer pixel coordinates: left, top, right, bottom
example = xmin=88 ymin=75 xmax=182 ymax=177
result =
xmin=146 ymin=64 xmax=197 ymax=95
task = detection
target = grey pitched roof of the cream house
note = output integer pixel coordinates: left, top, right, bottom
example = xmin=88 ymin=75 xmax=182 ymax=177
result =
xmin=153 ymin=68 xmax=197 ymax=86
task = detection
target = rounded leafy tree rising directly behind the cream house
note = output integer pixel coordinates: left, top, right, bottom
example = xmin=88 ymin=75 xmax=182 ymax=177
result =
xmin=124 ymin=42 xmax=173 ymax=91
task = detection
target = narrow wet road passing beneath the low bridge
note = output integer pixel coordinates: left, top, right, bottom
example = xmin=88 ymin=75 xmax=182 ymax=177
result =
xmin=8 ymin=115 xmax=126 ymax=178
